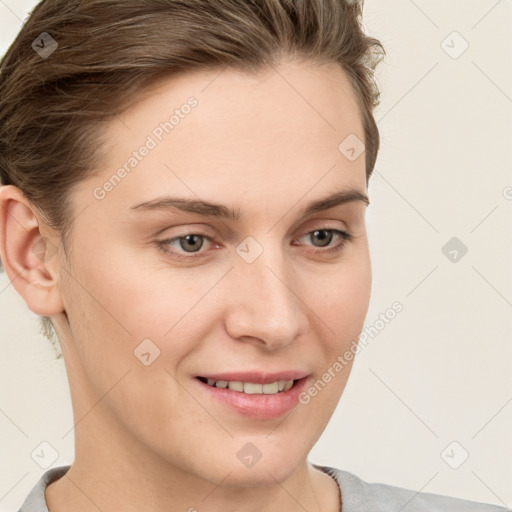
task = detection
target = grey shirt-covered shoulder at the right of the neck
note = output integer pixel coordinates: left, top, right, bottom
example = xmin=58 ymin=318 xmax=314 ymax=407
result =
xmin=313 ymin=464 xmax=512 ymax=512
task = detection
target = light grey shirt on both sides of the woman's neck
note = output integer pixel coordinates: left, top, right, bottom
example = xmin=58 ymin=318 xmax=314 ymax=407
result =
xmin=18 ymin=464 xmax=512 ymax=512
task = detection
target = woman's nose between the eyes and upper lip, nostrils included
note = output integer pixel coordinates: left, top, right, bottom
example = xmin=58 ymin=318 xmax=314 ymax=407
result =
xmin=225 ymin=242 xmax=308 ymax=350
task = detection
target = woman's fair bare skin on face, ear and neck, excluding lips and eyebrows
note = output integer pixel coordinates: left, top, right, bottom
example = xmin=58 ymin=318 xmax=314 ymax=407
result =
xmin=0 ymin=60 xmax=371 ymax=512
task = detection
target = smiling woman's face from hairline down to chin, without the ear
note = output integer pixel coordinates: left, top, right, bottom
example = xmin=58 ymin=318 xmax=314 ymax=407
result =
xmin=51 ymin=58 xmax=371 ymax=486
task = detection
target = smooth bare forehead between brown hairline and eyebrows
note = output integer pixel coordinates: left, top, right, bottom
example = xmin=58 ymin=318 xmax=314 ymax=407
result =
xmin=82 ymin=61 xmax=366 ymax=216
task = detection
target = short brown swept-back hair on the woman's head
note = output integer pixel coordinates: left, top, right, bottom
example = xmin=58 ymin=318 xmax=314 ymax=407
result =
xmin=0 ymin=0 xmax=385 ymax=352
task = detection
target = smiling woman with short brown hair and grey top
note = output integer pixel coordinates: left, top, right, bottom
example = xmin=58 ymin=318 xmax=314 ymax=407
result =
xmin=0 ymin=0 xmax=506 ymax=512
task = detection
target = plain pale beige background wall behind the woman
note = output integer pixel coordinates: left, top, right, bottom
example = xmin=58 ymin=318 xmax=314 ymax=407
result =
xmin=0 ymin=0 xmax=512 ymax=510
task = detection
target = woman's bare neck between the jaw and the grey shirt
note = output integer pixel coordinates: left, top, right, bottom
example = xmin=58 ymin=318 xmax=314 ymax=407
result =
xmin=45 ymin=440 xmax=341 ymax=512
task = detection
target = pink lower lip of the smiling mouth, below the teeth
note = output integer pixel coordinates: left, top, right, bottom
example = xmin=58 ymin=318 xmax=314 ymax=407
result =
xmin=193 ymin=377 xmax=308 ymax=420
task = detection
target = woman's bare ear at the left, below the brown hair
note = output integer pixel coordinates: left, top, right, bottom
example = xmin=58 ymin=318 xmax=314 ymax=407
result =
xmin=0 ymin=185 xmax=64 ymax=316
